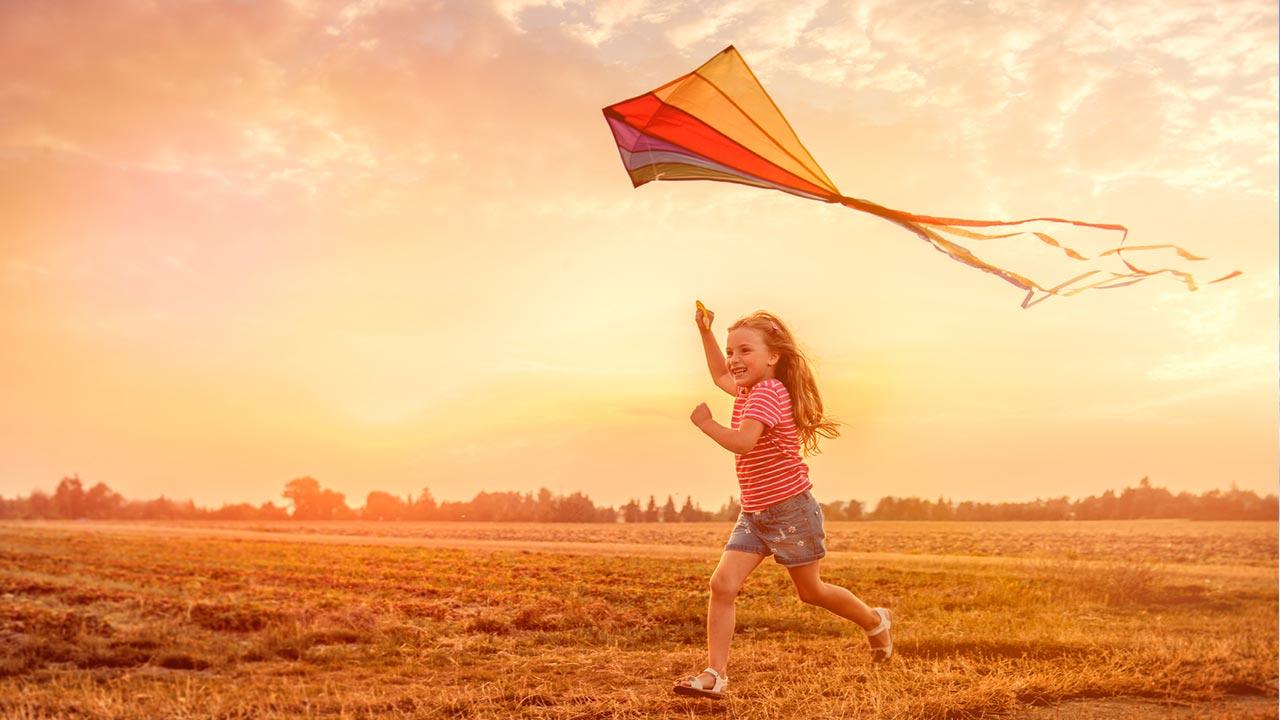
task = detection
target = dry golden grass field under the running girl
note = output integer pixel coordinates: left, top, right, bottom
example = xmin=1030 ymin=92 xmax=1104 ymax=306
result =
xmin=0 ymin=521 xmax=1277 ymax=719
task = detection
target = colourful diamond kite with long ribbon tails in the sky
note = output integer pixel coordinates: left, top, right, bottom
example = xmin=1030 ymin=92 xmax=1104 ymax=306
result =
xmin=604 ymin=45 xmax=1240 ymax=309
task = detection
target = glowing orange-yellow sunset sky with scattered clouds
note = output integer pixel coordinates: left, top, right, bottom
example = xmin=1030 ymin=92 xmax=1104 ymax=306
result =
xmin=0 ymin=0 xmax=1280 ymax=509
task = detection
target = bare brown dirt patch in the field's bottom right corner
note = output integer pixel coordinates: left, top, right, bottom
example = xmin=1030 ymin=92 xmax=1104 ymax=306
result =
xmin=1010 ymin=697 xmax=1276 ymax=720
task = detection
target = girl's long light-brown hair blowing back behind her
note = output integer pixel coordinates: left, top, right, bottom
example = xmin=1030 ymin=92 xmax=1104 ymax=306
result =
xmin=728 ymin=310 xmax=840 ymax=455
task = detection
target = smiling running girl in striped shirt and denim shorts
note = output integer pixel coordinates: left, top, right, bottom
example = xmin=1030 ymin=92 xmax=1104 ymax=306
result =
xmin=675 ymin=302 xmax=893 ymax=698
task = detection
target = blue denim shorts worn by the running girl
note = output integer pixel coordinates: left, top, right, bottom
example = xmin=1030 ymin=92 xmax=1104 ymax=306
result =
xmin=724 ymin=491 xmax=827 ymax=568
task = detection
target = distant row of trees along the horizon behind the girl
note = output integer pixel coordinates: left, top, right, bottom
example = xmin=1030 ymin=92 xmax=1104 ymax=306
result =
xmin=0 ymin=475 xmax=1280 ymax=523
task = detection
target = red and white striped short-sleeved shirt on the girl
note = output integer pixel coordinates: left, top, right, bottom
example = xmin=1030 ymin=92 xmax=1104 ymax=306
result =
xmin=731 ymin=378 xmax=813 ymax=512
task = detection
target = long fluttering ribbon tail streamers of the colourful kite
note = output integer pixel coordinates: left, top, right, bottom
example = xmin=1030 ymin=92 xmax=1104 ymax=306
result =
xmin=828 ymin=196 xmax=1242 ymax=309
